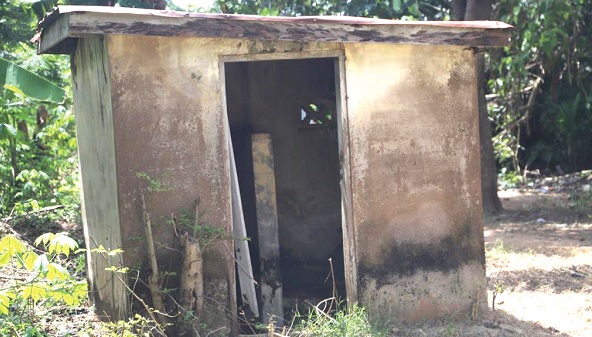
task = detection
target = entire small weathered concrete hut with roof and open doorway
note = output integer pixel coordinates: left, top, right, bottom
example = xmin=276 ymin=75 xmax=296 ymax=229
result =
xmin=39 ymin=6 xmax=510 ymax=335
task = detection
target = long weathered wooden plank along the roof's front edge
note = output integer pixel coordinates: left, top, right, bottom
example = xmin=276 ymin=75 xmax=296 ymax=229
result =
xmin=70 ymin=13 xmax=508 ymax=47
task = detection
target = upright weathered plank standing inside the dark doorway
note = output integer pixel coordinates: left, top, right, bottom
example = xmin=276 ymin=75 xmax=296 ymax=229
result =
xmin=251 ymin=133 xmax=284 ymax=326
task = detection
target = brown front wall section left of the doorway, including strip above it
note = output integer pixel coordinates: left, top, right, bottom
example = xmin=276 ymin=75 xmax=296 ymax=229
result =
xmin=107 ymin=35 xmax=338 ymax=329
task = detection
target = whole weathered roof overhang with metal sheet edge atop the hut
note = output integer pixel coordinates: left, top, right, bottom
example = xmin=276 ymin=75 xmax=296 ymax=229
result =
xmin=37 ymin=6 xmax=512 ymax=54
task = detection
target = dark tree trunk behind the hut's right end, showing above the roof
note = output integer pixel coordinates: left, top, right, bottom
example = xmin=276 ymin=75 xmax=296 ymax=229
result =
xmin=452 ymin=0 xmax=502 ymax=214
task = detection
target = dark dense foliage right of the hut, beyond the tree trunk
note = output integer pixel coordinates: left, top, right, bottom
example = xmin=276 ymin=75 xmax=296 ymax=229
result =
xmin=489 ymin=0 xmax=592 ymax=178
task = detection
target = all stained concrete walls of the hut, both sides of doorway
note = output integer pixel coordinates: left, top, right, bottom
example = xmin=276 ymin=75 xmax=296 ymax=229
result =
xmin=74 ymin=35 xmax=485 ymax=333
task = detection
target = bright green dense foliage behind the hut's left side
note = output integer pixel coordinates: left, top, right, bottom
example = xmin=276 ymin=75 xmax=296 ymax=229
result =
xmin=0 ymin=0 xmax=78 ymax=215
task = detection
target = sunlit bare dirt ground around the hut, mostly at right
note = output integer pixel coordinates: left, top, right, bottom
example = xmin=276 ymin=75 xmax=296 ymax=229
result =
xmin=0 ymin=171 xmax=592 ymax=337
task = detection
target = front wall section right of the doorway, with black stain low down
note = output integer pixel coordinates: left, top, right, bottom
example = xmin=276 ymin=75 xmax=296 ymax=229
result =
xmin=345 ymin=44 xmax=486 ymax=321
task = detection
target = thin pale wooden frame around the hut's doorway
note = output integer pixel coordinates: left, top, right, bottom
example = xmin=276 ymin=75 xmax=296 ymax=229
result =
xmin=218 ymin=49 xmax=358 ymax=310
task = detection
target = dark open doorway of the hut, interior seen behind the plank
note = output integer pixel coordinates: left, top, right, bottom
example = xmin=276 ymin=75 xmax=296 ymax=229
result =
xmin=223 ymin=57 xmax=346 ymax=322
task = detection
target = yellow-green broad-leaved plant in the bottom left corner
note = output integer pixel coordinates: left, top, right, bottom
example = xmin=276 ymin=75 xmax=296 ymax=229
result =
xmin=0 ymin=233 xmax=87 ymax=336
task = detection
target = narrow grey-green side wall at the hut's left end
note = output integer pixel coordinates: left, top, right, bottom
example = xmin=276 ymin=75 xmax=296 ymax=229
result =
xmin=72 ymin=38 xmax=129 ymax=319
